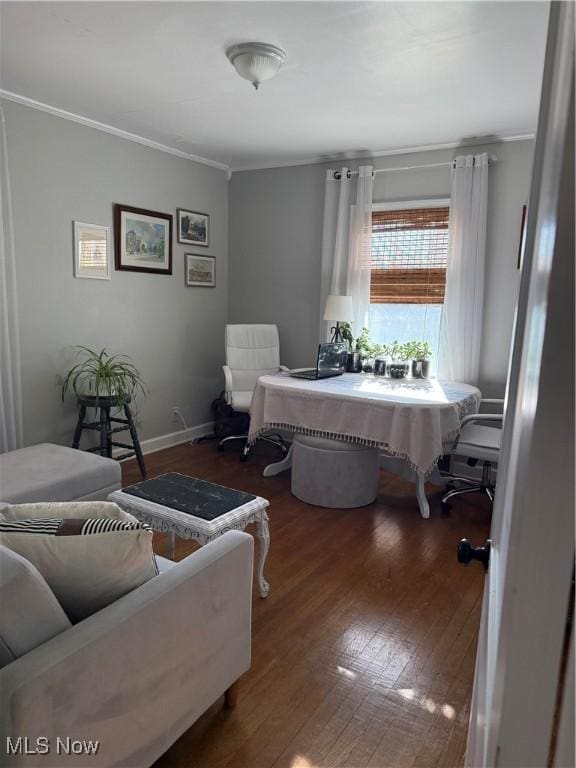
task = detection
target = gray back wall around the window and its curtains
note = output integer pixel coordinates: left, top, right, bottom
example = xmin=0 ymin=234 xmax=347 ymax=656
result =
xmin=229 ymin=136 xmax=534 ymax=395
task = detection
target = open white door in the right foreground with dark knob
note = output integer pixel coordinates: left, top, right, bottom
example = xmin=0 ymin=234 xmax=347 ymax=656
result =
xmin=466 ymin=2 xmax=574 ymax=768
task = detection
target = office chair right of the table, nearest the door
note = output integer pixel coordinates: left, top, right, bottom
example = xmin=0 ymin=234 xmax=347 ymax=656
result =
xmin=441 ymin=398 xmax=504 ymax=514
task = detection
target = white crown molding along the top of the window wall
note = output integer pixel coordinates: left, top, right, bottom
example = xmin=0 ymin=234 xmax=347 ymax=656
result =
xmin=232 ymin=133 xmax=535 ymax=173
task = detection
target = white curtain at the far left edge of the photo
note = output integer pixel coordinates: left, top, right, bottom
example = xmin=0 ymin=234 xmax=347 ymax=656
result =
xmin=0 ymin=105 xmax=23 ymax=452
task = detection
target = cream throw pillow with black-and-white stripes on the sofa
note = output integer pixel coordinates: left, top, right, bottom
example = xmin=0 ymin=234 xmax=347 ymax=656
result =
xmin=0 ymin=501 xmax=158 ymax=622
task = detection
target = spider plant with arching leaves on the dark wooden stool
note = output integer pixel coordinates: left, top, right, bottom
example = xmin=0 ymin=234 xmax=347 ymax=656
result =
xmin=62 ymin=346 xmax=146 ymax=406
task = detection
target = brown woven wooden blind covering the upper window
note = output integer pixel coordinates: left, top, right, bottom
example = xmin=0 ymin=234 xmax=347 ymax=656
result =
xmin=370 ymin=207 xmax=450 ymax=304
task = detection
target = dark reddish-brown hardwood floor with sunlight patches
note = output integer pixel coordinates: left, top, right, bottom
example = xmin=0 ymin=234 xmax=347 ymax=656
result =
xmin=123 ymin=443 xmax=490 ymax=768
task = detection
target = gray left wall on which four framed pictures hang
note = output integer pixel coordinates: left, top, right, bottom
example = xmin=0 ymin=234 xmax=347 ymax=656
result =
xmin=3 ymin=101 xmax=228 ymax=445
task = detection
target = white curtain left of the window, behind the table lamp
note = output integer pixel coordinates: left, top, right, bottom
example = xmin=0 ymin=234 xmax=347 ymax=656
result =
xmin=320 ymin=165 xmax=374 ymax=340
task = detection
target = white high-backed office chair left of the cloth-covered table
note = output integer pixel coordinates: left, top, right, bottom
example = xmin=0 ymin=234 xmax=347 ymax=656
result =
xmin=218 ymin=324 xmax=288 ymax=461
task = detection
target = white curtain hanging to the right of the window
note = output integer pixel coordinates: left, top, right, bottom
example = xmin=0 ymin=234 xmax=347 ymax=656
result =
xmin=438 ymin=153 xmax=488 ymax=384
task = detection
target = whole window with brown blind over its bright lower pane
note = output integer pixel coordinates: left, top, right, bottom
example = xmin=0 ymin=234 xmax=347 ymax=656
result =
xmin=370 ymin=200 xmax=450 ymax=374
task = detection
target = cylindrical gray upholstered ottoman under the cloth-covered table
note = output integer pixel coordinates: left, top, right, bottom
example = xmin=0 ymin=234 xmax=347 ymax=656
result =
xmin=291 ymin=434 xmax=379 ymax=509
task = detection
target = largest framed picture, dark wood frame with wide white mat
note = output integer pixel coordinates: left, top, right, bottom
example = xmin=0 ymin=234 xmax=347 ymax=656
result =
xmin=114 ymin=203 xmax=172 ymax=275
